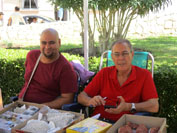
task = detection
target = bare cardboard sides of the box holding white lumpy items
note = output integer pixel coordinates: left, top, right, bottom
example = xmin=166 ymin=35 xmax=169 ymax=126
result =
xmin=12 ymin=110 xmax=84 ymax=133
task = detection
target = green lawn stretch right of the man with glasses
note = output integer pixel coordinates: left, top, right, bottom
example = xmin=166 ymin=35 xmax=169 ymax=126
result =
xmin=131 ymin=37 xmax=177 ymax=65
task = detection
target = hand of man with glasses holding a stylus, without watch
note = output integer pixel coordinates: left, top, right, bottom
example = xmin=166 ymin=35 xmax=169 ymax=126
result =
xmin=88 ymin=95 xmax=106 ymax=107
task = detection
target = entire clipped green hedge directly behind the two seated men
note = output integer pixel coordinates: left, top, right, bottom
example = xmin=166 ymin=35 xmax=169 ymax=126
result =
xmin=0 ymin=53 xmax=177 ymax=132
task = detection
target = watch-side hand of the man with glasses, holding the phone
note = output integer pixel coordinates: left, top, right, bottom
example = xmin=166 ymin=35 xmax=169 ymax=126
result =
xmin=105 ymin=96 xmax=131 ymax=114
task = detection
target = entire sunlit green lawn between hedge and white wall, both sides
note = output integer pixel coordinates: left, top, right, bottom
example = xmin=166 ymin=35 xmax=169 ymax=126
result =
xmin=0 ymin=36 xmax=177 ymax=65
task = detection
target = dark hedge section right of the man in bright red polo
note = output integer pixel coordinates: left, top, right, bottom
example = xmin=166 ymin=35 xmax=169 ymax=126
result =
xmin=154 ymin=65 xmax=177 ymax=132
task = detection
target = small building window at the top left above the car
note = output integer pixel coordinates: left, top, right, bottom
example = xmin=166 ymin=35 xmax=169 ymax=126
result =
xmin=23 ymin=0 xmax=37 ymax=9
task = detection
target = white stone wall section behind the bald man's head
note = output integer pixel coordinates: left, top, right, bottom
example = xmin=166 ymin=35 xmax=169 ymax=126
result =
xmin=0 ymin=21 xmax=81 ymax=46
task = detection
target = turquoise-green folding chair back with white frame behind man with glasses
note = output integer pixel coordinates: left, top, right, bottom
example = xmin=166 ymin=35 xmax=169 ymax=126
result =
xmin=99 ymin=50 xmax=154 ymax=77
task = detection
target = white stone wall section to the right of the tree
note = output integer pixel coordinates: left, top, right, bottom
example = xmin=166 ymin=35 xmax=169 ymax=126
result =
xmin=128 ymin=0 xmax=177 ymax=37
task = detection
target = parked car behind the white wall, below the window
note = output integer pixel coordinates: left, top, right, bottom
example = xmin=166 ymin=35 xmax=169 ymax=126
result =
xmin=23 ymin=15 xmax=55 ymax=24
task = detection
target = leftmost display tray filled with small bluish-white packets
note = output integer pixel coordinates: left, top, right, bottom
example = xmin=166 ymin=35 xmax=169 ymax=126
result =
xmin=0 ymin=100 xmax=44 ymax=132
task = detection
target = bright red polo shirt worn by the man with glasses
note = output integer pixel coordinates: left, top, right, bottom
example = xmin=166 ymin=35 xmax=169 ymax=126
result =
xmin=84 ymin=66 xmax=158 ymax=121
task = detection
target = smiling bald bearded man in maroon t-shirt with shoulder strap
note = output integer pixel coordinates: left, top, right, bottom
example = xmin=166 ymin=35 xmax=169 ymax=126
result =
xmin=19 ymin=28 xmax=77 ymax=109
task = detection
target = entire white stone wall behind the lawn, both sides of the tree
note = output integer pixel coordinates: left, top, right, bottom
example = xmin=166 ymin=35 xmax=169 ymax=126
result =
xmin=0 ymin=0 xmax=177 ymax=45
